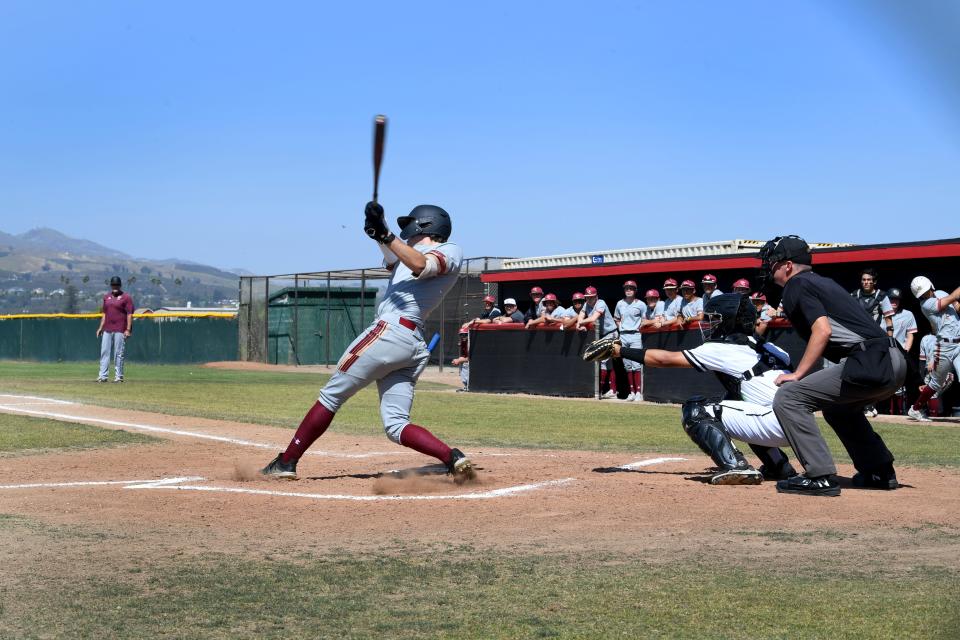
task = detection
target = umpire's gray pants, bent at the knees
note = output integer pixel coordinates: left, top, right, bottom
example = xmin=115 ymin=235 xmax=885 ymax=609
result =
xmin=773 ymin=347 xmax=907 ymax=477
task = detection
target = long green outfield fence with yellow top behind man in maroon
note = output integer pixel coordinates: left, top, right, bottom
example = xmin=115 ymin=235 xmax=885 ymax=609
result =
xmin=0 ymin=313 xmax=238 ymax=364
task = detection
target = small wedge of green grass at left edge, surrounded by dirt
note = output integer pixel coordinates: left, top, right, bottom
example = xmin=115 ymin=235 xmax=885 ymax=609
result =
xmin=0 ymin=415 xmax=158 ymax=455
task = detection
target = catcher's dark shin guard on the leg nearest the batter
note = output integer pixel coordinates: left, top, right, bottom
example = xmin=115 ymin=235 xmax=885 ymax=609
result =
xmin=682 ymin=396 xmax=763 ymax=484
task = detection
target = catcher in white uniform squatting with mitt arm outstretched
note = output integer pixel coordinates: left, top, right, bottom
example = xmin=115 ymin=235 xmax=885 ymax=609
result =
xmin=583 ymin=293 xmax=796 ymax=485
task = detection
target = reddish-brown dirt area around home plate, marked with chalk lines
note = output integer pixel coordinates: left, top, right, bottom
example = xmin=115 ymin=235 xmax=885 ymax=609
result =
xmin=0 ymin=396 xmax=960 ymax=564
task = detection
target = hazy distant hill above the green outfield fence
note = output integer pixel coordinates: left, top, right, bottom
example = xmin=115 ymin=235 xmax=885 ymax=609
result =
xmin=0 ymin=228 xmax=247 ymax=313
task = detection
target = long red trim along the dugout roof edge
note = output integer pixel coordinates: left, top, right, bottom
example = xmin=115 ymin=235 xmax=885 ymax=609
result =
xmin=480 ymin=242 xmax=960 ymax=282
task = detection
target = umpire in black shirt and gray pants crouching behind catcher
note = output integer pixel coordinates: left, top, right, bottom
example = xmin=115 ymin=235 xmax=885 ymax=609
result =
xmin=760 ymin=236 xmax=907 ymax=496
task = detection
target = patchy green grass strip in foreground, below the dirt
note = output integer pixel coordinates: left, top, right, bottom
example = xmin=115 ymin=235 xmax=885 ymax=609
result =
xmin=0 ymin=536 xmax=960 ymax=640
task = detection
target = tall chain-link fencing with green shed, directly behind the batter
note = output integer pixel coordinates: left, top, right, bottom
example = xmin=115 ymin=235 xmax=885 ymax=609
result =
xmin=239 ymin=257 xmax=504 ymax=367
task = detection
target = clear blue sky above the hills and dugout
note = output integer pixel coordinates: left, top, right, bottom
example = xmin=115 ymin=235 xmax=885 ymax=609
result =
xmin=0 ymin=0 xmax=960 ymax=273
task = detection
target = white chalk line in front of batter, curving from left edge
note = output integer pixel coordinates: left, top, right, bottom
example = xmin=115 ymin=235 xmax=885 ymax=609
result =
xmin=0 ymin=476 xmax=575 ymax=502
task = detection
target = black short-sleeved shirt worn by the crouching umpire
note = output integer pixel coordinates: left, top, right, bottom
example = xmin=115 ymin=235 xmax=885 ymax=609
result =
xmin=783 ymin=271 xmax=887 ymax=362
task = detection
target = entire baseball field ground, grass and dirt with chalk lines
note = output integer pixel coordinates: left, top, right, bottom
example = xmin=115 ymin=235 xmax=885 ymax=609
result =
xmin=0 ymin=362 xmax=960 ymax=640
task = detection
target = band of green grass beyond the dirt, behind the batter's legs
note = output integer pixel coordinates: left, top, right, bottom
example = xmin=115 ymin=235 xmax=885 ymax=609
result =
xmin=0 ymin=362 xmax=960 ymax=467
